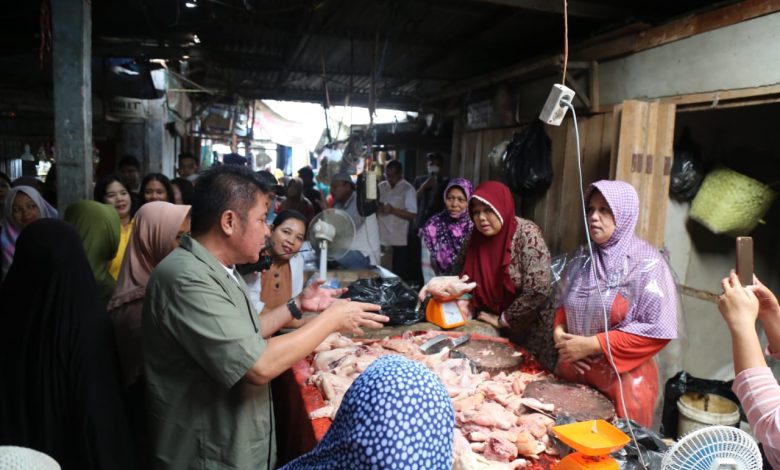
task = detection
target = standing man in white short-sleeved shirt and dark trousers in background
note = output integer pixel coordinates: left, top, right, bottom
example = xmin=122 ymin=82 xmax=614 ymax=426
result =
xmin=377 ymin=160 xmax=419 ymax=278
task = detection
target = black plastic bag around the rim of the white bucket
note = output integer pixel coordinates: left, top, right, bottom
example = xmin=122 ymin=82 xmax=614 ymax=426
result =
xmin=661 ymin=371 xmax=745 ymax=439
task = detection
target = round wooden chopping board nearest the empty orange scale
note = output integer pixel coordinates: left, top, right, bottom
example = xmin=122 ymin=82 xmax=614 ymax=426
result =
xmin=523 ymin=379 xmax=615 ymax=421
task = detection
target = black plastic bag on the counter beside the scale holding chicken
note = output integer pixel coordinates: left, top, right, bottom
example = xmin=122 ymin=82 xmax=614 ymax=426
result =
xmin=342 ymin=277 xmax=425 ymax=325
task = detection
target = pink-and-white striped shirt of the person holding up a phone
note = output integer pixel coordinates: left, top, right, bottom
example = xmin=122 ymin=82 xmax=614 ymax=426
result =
xmin=732 ymin=353 xmax=780 ymax=469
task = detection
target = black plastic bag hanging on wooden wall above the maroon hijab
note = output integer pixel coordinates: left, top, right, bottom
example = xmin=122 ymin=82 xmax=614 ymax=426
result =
xmin=504 ymin=119 xmax=553 ymax=196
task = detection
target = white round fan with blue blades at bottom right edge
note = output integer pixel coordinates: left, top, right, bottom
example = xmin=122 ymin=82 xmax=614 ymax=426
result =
xmin=661 ymin=426 xmax=761 ymax=470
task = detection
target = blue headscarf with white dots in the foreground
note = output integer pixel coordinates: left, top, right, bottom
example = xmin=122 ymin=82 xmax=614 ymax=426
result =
xmin=281 ymin=355 xmax=455 ymax=470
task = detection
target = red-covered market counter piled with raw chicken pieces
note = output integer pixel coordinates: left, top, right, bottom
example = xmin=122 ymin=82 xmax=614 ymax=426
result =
xmin=274 ymin=328 xmax=600 ymax=468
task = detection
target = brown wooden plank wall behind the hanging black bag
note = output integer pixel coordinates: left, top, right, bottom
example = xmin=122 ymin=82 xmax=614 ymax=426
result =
xmin=458 ymin=113 xmax=614 ymax=255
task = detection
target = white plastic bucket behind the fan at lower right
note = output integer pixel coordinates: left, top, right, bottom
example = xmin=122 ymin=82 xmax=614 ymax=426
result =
xmin=677 ymin=393 xmax=739 ymax=437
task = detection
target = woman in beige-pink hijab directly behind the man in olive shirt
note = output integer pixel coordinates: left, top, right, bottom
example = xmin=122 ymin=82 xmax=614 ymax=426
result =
xmin=108 ymin=201 xmax=191 ymax=387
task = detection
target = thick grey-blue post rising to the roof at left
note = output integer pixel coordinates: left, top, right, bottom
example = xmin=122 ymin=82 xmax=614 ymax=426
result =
xmin=51 ymin=0 xmax=92 ymax=211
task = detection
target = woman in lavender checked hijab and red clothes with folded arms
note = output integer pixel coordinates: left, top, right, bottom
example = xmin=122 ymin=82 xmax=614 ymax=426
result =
xmin=553 ymin=180 xmax=677 ymax=426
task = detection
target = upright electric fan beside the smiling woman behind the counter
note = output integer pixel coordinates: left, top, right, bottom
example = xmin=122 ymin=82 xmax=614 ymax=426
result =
xmin=309 ymin=209 xmax=355 ymax=279
